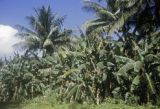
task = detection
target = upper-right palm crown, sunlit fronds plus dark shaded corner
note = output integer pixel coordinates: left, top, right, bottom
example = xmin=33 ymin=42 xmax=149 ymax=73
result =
xmin=84 ymin=0 xmax=160 ymax=37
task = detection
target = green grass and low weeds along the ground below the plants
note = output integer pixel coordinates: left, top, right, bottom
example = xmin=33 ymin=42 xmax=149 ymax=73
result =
xmin=0 ymin=95 xmax=159 ymax=109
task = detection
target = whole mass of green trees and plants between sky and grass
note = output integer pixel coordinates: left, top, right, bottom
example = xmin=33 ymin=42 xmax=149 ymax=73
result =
xmin=0 ymin=0 xmax=160 ymax=107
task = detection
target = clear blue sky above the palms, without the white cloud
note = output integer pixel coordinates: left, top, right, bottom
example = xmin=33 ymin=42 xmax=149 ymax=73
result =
xmin=0 ymin=0 xmax=94 ymax=28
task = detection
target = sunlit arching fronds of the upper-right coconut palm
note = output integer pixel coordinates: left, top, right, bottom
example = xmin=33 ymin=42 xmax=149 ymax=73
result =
xmin=84 ymin=0 xmax=141 ymax=33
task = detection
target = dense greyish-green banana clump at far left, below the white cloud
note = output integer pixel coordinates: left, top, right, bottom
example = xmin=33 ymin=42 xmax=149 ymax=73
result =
xmin=0 ymin=55 xmax=50 ymax=101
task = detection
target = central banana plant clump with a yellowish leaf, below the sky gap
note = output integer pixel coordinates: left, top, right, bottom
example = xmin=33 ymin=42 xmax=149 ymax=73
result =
xmin=47 ymin=35 xmax=116 ymax=104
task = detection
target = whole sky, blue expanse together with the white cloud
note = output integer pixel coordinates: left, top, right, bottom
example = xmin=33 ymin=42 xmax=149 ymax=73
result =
xmin=0 ymin=0 xmax=93 ymax=57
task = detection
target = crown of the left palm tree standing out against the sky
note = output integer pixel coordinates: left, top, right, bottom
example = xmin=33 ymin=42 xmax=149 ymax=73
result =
xmin=16 ymin=6 xmax=72 ymax=55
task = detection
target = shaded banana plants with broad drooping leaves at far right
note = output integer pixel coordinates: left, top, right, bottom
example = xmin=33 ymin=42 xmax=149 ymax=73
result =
xmin=116 ymin=36 xmax=160 ymax=103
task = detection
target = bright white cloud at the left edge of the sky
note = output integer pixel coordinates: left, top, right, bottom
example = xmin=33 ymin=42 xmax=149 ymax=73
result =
xmin=0 ymin=24 xmax=19 ymax=57
